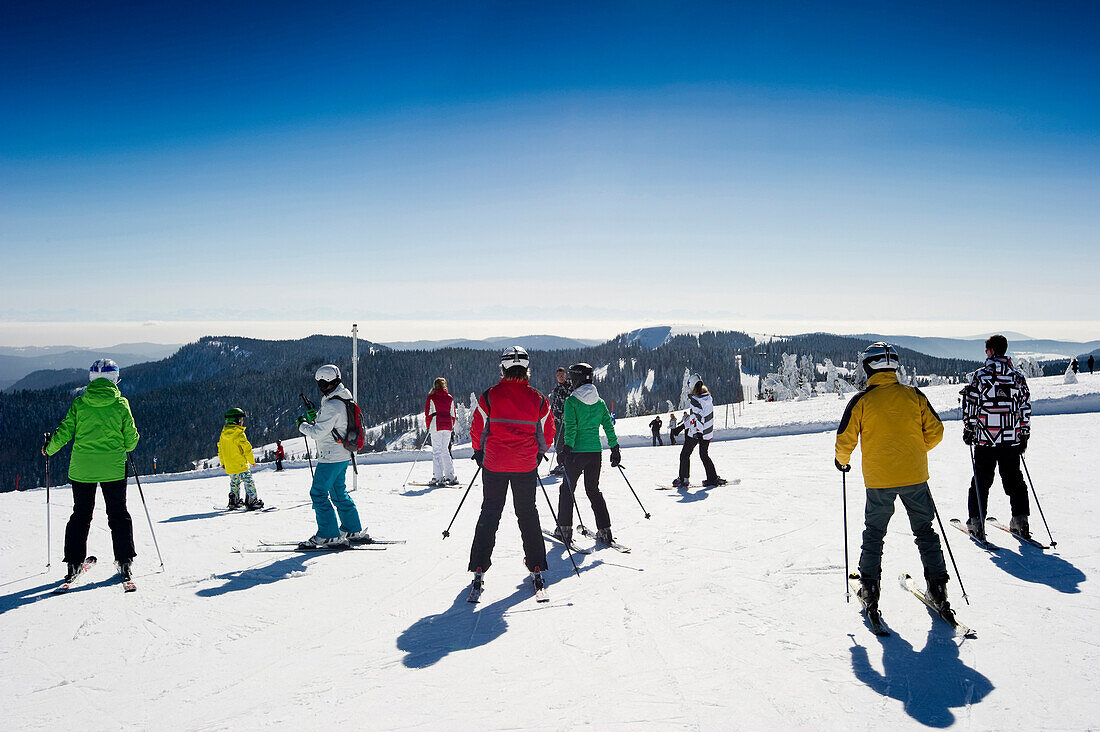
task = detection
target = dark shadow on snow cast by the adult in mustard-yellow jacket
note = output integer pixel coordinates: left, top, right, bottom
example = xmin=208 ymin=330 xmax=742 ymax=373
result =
xmin=850 ymin=615 xmax=993 ymax=728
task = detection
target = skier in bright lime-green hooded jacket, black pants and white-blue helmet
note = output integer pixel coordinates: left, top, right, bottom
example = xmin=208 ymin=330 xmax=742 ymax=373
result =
xmin=42 ymin=359 xmax=140 ymax=582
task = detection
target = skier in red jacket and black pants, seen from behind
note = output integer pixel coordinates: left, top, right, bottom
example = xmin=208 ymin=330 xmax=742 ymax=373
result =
xmin=470 ymin=346 xmax=554 ymax=592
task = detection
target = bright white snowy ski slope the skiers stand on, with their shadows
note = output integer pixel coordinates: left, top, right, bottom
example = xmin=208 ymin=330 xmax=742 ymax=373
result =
xmin=0 ymin=379 xmax=1100 ymax=732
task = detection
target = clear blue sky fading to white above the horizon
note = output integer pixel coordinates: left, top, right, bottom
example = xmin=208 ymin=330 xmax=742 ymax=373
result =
xmin=0 ymin=0 xmax=1100 ymax=345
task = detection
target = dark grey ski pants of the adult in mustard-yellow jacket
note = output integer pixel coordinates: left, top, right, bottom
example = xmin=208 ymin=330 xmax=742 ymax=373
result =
xmin=859 ymin=482 xmax=949 ymax=582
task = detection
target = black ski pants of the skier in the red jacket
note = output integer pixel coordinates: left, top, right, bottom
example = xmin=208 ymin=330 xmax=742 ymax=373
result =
xmin=470 ymin=468 xmax=547 ymax=572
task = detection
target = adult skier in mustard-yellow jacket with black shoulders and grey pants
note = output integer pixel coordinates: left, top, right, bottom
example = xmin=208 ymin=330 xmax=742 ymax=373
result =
xmin=833 ymin=342 xmax=950 ymax=615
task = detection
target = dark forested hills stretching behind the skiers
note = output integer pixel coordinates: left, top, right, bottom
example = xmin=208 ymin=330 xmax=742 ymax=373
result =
xmin=0 ymin=331 xmax=976 ymax=490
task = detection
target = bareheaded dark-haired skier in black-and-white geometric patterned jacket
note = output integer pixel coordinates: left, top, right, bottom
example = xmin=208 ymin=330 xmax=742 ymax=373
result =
xmin=959 ymin=335 xmax=1031 ymax=539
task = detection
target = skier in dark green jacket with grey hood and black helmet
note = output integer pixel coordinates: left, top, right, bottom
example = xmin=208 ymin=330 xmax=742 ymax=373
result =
xmin=554 ymin=363 xmax=622 ymax=544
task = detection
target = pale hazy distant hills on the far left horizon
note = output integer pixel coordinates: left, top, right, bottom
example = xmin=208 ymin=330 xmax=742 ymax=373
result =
xmin=0 ymin=343 xmax=179 ymax=390
